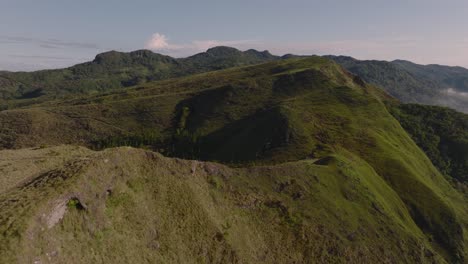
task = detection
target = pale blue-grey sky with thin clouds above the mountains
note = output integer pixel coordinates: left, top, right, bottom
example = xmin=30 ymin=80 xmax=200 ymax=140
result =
xmin=0 ymin=0 xmax=468 ymax=71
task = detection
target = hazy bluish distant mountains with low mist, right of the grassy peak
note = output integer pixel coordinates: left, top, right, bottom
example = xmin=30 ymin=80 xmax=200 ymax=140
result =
xmin=326 ymin=56 xmax=468 ymax=113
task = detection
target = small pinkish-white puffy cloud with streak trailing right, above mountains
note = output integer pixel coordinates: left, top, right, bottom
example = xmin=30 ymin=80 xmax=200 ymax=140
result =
xmin=145 ymin=33 xmax=257 ymax=56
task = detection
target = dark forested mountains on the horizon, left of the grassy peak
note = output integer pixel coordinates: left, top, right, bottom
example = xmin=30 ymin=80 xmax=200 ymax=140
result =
xmin=0 ymin=47 xmax=279 ymax=103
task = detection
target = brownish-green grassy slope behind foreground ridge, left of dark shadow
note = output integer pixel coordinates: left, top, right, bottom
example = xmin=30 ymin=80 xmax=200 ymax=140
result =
xmin=0 ymin=57 xmax=334 ymax=151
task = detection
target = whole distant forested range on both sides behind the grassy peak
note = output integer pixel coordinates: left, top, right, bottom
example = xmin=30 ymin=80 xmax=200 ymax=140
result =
xmin=0 ymin=47 xmax=468 ymax=113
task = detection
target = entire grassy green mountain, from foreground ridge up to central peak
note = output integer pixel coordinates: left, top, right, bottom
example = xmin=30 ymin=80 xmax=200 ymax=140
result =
xmin=0 ymin=55 xmax=468 ymax=263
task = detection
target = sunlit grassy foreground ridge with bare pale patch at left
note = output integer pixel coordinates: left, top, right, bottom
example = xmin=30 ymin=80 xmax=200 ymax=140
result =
xmin=0 ymin=147 xmax=458 ymax=263
